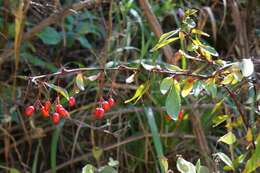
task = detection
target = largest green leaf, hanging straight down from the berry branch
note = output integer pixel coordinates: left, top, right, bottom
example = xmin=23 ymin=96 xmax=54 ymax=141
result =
xmin=165 ymin=81 xmax=181 ymax=121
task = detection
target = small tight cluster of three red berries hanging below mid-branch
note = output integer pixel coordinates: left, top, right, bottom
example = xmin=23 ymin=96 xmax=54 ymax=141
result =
xmin=93 ymin=97 xmax=115 ymax=119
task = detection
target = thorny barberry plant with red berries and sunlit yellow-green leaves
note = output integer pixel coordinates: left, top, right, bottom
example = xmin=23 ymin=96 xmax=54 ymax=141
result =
xmin=25 ymin=9 xmax=260 ymax=172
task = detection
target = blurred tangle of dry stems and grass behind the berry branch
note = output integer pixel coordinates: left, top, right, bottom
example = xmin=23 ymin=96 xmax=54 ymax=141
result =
xmin=0 ymin=0 xmax=260 ymax=173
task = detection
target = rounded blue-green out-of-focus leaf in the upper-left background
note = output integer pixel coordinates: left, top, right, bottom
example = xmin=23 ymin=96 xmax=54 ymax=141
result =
xmin=38 ymin=27 xmax=61 ymax=45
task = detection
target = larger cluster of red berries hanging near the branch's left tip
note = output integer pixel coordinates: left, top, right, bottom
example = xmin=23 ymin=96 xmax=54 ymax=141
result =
xmin=25 ymin=97 xmax=76 ymax=125
